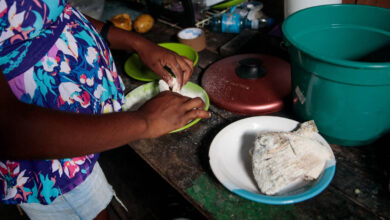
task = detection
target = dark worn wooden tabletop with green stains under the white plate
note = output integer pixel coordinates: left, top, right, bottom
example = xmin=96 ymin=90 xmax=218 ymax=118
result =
xmin=114 ymin=22 xmax=390 ymax=219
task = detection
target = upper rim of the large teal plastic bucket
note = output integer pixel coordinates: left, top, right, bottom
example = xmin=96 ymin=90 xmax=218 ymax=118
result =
xmin=282 ymin=4 xmax=390 ymax=69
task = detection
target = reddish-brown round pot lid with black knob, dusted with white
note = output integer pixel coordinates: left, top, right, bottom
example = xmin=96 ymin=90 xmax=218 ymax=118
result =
xmin=202 ymin=54 xmax=291 ymax=115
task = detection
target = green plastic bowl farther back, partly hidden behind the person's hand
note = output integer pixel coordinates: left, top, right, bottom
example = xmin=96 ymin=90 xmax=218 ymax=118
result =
xmin=124 ymin=43 xmax=199 ymax=82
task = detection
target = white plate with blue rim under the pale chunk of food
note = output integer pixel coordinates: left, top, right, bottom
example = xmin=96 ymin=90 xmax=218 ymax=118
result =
xmin=209 ymin=116 xmax=335 ymax=204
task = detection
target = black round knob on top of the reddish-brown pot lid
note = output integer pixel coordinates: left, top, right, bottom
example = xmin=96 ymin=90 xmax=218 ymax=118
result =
xmin=236 ymin=58 xmax=267 ymax=79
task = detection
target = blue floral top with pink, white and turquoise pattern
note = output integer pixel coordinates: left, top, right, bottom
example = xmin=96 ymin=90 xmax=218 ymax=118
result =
xmin=0 ymin=0 xmax=124 ymax=204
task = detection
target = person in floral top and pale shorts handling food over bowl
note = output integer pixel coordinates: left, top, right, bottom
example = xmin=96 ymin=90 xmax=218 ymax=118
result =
xmin=0 ymin=0 xmax=210 ymax=220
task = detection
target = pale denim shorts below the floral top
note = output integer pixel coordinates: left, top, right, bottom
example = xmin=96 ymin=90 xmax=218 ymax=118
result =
xmin=20 ymin=163 xmax=115 ymax=220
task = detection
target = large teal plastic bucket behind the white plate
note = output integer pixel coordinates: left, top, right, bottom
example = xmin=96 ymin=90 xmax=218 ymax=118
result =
xmin=282 ymin=4 xmax=390 ymax=146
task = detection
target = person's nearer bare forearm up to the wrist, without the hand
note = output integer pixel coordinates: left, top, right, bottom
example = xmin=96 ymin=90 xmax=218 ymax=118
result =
xmin=0 ymin=99 xmax=146 ymax=159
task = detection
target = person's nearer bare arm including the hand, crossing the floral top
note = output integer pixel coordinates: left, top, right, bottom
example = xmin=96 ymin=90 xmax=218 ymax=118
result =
xmin=0 ymin=71 xmax=209 ymax=159
